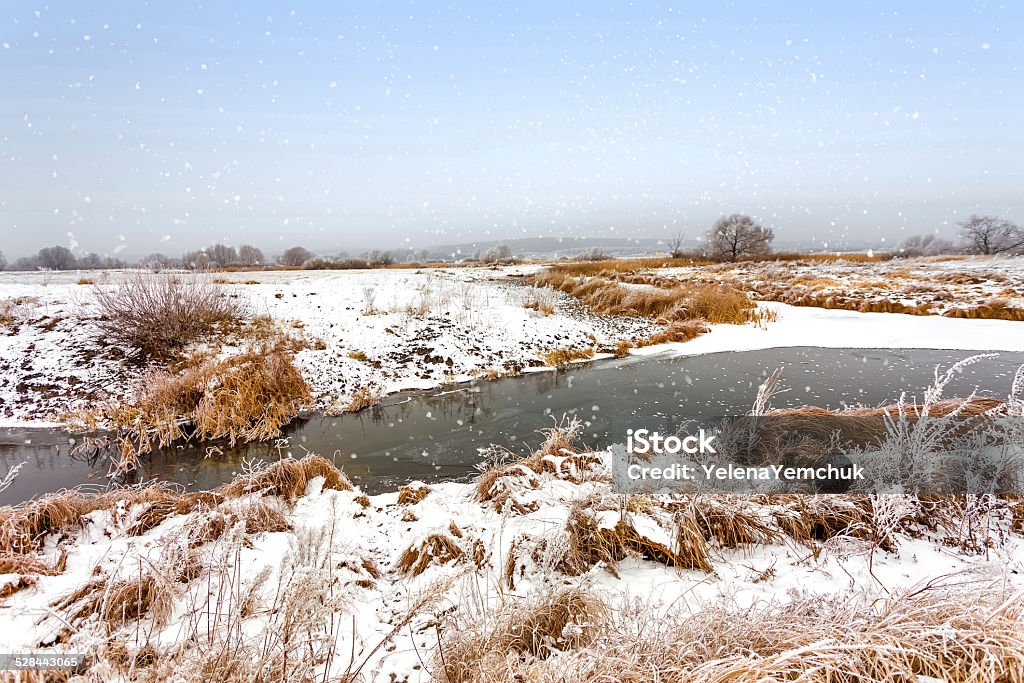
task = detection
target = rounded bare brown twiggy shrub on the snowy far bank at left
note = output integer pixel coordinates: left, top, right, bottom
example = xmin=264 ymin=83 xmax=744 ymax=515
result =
xmin=93 ymin=273 xmax=246 ymax=358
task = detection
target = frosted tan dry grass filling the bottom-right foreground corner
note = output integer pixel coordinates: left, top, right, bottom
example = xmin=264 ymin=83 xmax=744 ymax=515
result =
xmin=435 ymin=583 xmax=1024 ymax=683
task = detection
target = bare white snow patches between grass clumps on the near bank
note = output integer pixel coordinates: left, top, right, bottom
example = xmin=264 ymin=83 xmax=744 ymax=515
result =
xmin=0 ymin=454 xmax=1024 ymax=681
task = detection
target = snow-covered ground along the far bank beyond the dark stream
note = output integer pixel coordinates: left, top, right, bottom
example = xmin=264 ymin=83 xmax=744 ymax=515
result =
xmin=0 ymin=259 xmax=1024 ymax=425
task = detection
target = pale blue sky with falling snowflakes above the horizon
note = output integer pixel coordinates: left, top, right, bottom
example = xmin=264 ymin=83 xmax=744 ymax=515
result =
xmin=0 ymin=0 xmax=1024 ymax=258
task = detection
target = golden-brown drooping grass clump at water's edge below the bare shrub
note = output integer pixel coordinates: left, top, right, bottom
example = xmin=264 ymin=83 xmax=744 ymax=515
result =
xmin=66 ymin=345 xmax=311 ymax=465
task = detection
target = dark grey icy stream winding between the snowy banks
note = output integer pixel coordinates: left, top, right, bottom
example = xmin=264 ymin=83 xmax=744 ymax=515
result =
xmin=0 ymin=348 xmax=1024 ymax=505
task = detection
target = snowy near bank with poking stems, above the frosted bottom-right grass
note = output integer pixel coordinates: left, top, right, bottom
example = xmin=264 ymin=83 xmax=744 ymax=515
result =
xmin=0 ymin=456 xmax=1024 ymax=681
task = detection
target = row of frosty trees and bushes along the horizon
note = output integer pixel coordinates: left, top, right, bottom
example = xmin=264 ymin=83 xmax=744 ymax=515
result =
xmin=0 ymin=213 xmax=1024 ymax=270
